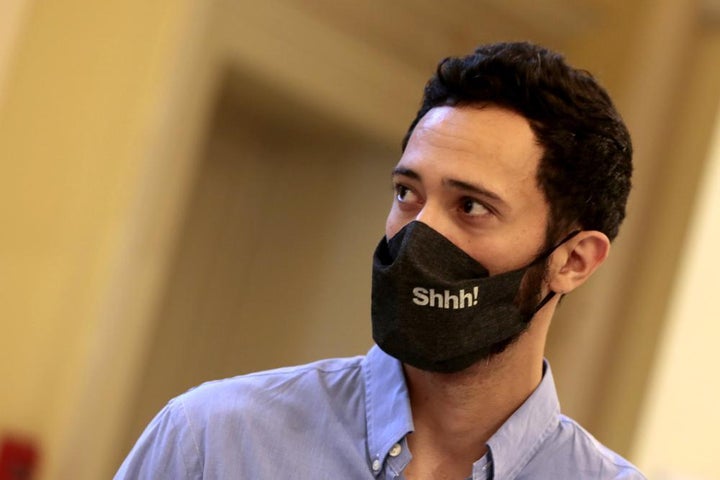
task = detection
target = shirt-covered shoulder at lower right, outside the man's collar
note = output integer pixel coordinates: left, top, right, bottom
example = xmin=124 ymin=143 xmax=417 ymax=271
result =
xmin=535 ymin=415 xmax=646 ymax=480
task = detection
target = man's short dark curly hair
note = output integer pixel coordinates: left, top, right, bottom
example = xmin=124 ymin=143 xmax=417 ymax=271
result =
xmin=402 ymin=42 xmax=632 ymax=244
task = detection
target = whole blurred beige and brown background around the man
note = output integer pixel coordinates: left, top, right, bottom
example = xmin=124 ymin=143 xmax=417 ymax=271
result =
xmin=0 ymin=0 xmax=720 ymax=480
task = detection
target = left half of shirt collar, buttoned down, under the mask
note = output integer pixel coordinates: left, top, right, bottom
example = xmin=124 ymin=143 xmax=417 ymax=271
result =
xmin=363 ymin=345 xmax=414 ymax=472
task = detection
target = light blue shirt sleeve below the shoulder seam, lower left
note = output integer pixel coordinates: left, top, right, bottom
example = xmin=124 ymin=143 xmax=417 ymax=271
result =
xmin=114 ymin=399 xmax=203 ymax=480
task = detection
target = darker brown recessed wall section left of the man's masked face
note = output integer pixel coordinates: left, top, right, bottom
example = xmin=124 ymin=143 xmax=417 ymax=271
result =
xmin=116 ymin=78 xmax=397 ymax=462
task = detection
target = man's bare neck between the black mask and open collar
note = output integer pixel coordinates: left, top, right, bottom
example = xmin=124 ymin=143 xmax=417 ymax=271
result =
xmin=405 ymin=337 xmax=542 ymax=480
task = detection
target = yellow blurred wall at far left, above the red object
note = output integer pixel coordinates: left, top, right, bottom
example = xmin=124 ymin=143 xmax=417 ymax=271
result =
xmin=0 ymin=0 xmax=217 ymax=479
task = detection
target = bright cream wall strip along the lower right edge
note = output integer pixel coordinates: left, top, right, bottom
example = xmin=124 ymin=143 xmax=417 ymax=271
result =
xmin=633 ymin=99 xmax=720 ymax=480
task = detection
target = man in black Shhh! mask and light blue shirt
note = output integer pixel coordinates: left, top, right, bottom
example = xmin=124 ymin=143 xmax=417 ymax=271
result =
xmin=116 ymin=43 xmax=644 ymax=480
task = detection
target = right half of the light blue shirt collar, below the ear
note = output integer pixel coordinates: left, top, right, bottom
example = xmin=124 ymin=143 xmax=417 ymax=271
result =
xmin=488 ymin=360 xmax=560 ymax=479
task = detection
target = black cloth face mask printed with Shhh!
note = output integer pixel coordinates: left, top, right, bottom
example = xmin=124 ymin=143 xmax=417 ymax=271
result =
xmin=372 ymin=221 xmax=579 ymax=372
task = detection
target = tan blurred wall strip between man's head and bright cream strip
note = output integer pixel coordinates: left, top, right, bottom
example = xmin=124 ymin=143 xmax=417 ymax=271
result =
xmin=550 ymin=0 xmax=720 ymax=452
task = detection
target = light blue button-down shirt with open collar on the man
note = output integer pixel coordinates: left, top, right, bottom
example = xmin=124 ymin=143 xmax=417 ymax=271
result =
xmin=115 ymin=347 xmax=645 ymax=480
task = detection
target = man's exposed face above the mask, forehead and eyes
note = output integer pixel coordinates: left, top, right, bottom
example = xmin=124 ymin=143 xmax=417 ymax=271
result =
xmin=385 ymin=106 xmax=549 ymax=275
